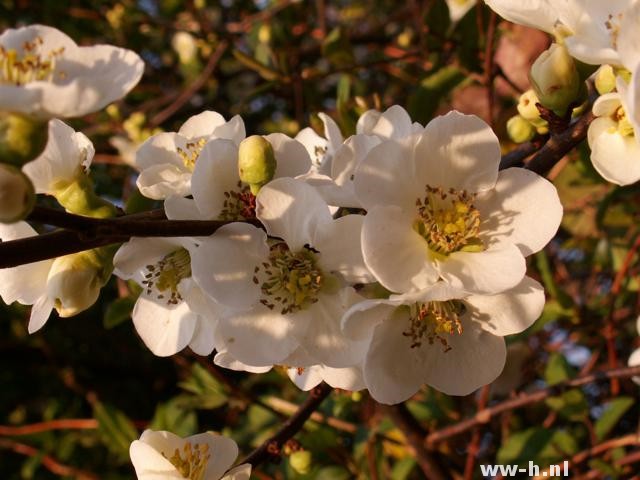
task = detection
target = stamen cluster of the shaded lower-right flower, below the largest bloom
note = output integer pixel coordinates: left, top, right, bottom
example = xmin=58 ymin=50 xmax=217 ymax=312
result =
xmin=402 ymin=300 xmax=466 ymax=352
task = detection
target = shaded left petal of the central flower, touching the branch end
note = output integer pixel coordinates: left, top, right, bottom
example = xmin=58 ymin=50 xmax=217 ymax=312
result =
xmin=190 ymin=223 xmax=269 ymax=309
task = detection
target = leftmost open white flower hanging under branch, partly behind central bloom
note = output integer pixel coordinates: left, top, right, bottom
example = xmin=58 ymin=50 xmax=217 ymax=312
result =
xmin=113 ymin=238 xmax=220 ymax=357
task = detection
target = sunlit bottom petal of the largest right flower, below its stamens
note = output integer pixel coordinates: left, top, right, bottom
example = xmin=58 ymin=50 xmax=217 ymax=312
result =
xmin=438 ymin=245 xmax=526 ymax=294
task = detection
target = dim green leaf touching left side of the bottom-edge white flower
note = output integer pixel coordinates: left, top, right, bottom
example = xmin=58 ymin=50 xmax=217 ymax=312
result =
xmin=93 ymin=402 xmax=138 ymax=461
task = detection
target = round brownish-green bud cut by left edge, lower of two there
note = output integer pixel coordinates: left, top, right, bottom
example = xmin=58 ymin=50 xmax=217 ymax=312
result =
xmin=0 ymin=163 xmax=36 ymax=223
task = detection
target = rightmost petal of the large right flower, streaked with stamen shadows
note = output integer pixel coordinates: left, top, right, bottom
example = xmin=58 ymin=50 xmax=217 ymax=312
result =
xmin=474 ymin=168 xmax=562 ymax=256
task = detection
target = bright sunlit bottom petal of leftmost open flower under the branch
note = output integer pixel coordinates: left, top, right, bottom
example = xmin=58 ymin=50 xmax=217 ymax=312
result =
xmin=131 ymin=295 xmax=198 ymax=357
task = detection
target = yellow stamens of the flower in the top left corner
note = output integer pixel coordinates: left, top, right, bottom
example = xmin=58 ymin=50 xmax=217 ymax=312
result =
xmin=0 ymin=37 xmax=64 ymax=86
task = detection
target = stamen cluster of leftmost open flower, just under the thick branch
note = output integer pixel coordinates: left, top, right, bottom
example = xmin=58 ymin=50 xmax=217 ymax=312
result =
xmin=142 ymin=248 xmax=191 ymax=305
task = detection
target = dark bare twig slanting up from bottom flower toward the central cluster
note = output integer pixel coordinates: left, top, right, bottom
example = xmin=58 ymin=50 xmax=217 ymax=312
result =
xmin=240 ymin=383 xmax=333 ymax=467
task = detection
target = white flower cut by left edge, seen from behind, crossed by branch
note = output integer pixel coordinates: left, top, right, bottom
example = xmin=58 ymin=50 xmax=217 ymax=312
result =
xmin=0 ymin=222 xmax=111 ymax=333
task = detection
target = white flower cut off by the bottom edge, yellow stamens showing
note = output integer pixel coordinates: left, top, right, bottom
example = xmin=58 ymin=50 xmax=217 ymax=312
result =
xmin=129 ymin=430 xmax=251 ymax=480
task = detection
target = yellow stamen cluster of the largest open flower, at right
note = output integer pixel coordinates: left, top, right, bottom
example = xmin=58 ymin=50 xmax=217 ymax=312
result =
xmin=413 ymin=185 xmax=484 ymax=256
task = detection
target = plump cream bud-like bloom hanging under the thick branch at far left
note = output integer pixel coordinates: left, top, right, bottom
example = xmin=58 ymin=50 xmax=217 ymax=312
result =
xmin=47 ymin=249 xmax=112 ymax=317
